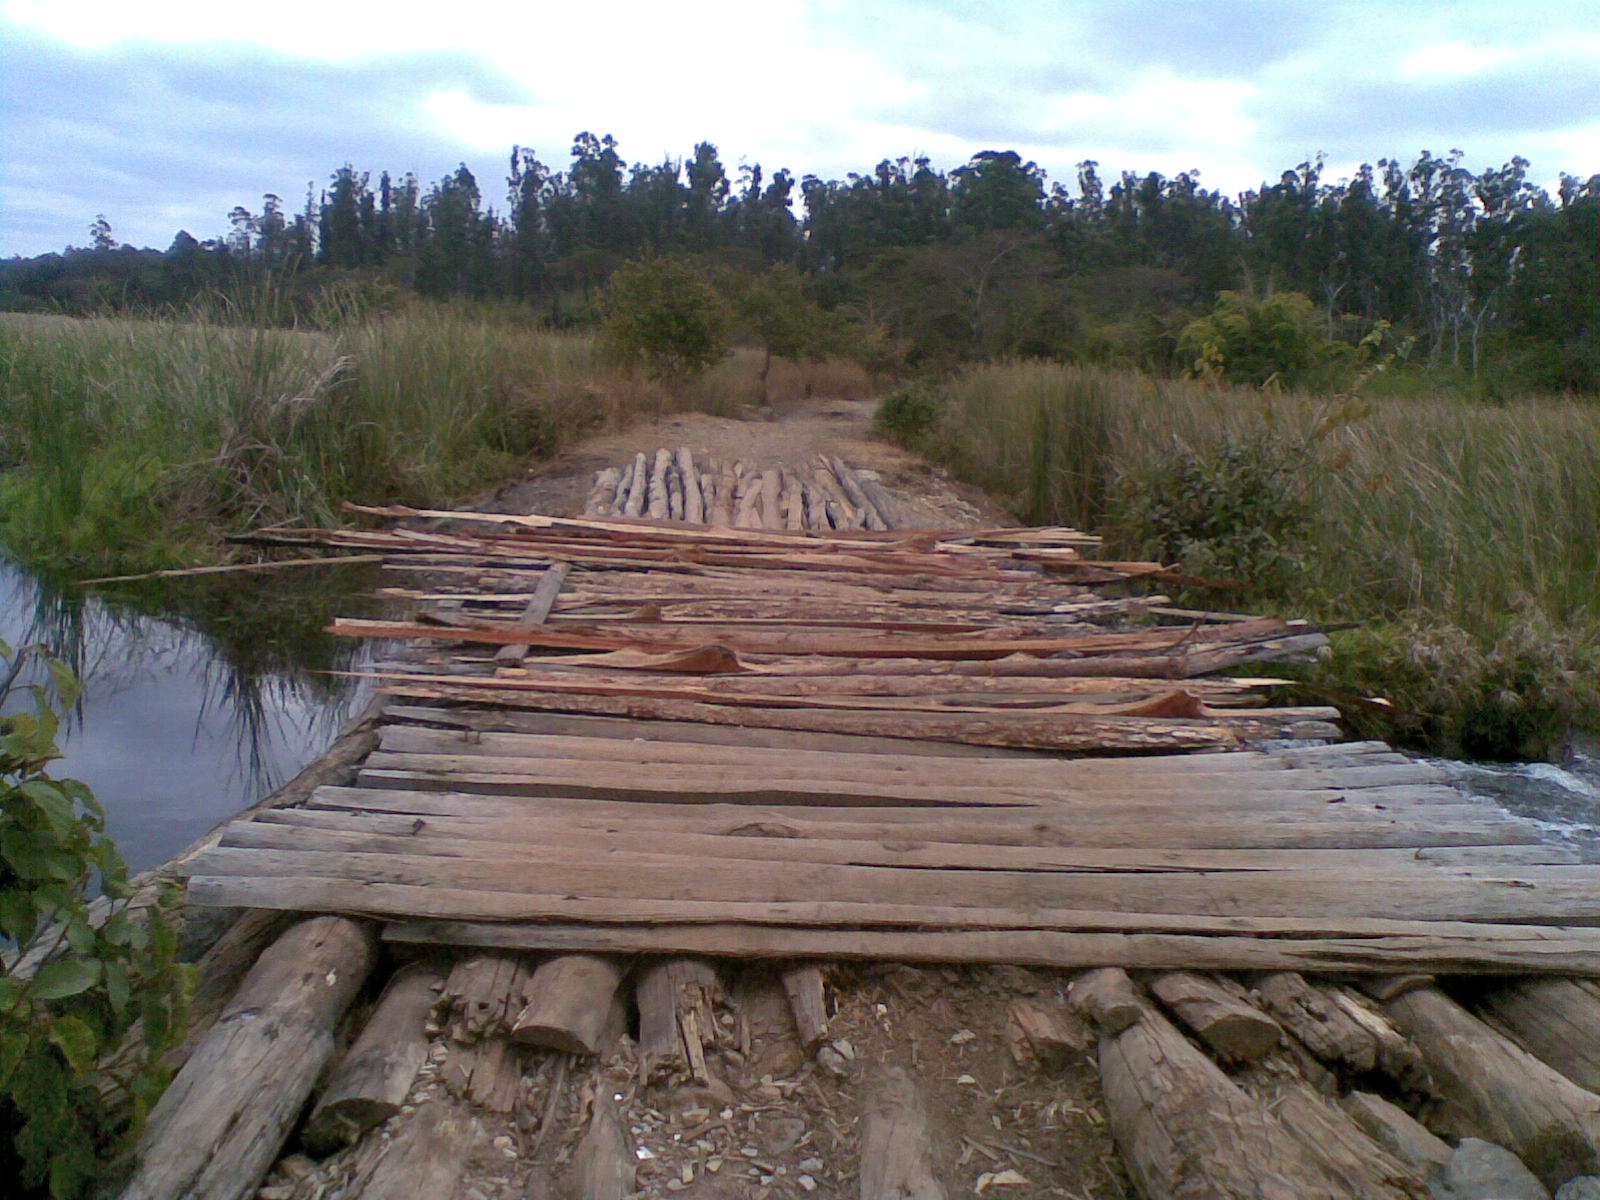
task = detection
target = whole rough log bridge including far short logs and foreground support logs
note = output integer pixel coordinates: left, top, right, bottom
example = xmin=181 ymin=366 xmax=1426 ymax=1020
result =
xmin=123 ymin=451 xmax=1600 ymax=1200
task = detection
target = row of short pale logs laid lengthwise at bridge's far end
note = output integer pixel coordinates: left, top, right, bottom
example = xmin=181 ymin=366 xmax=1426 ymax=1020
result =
xmin=584 ymin=446 xmax=907 ymax=533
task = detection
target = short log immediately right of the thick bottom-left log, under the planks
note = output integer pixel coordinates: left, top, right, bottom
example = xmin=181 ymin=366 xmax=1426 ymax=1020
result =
xmin=301 ymin=963 xmax=443 ymax=1155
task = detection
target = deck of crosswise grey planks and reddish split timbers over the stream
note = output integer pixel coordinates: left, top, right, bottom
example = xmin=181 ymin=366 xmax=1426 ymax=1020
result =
xmin=190 ymin=460 xmax=1600 ymax=974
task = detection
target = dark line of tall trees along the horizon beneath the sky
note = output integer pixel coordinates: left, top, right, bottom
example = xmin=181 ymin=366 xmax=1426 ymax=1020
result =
xmin=0 ymin=133 xmax=1600 ymax=390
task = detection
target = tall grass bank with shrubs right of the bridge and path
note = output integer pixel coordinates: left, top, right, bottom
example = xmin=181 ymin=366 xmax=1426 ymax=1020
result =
xmin=882 ymin=363 xmax=1600 ymax=757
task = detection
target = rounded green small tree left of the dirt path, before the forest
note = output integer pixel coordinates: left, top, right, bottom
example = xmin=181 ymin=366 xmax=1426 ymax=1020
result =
xmin=605 ymin=258 xmax=728 ymax=382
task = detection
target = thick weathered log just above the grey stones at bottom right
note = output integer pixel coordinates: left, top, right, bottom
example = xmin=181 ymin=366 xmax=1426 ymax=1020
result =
xmin=1387 ymin=987 xmax=1600 ymax=1187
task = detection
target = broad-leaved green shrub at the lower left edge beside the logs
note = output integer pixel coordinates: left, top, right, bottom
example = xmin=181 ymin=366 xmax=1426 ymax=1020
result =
xmin=0 ymin=642 xmax=187 ymax=1200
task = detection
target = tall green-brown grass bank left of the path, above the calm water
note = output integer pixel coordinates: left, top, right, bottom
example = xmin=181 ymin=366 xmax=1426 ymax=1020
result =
xmin=0 ymin=306 xmax=870 ymax=574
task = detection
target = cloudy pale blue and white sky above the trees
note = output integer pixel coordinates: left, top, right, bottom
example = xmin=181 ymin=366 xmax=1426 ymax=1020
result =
xmin=0 ymin=0 xmax=1600 ymax=254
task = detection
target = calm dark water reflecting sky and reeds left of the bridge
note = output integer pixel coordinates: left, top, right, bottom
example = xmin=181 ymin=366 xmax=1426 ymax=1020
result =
xmin=0 ymin=558 xmax=373 ymax=870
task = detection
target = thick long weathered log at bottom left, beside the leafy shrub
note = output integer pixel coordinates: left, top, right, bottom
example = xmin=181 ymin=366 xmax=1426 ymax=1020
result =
xmin=122 ymin=917 xmax=378 ymax=1200
